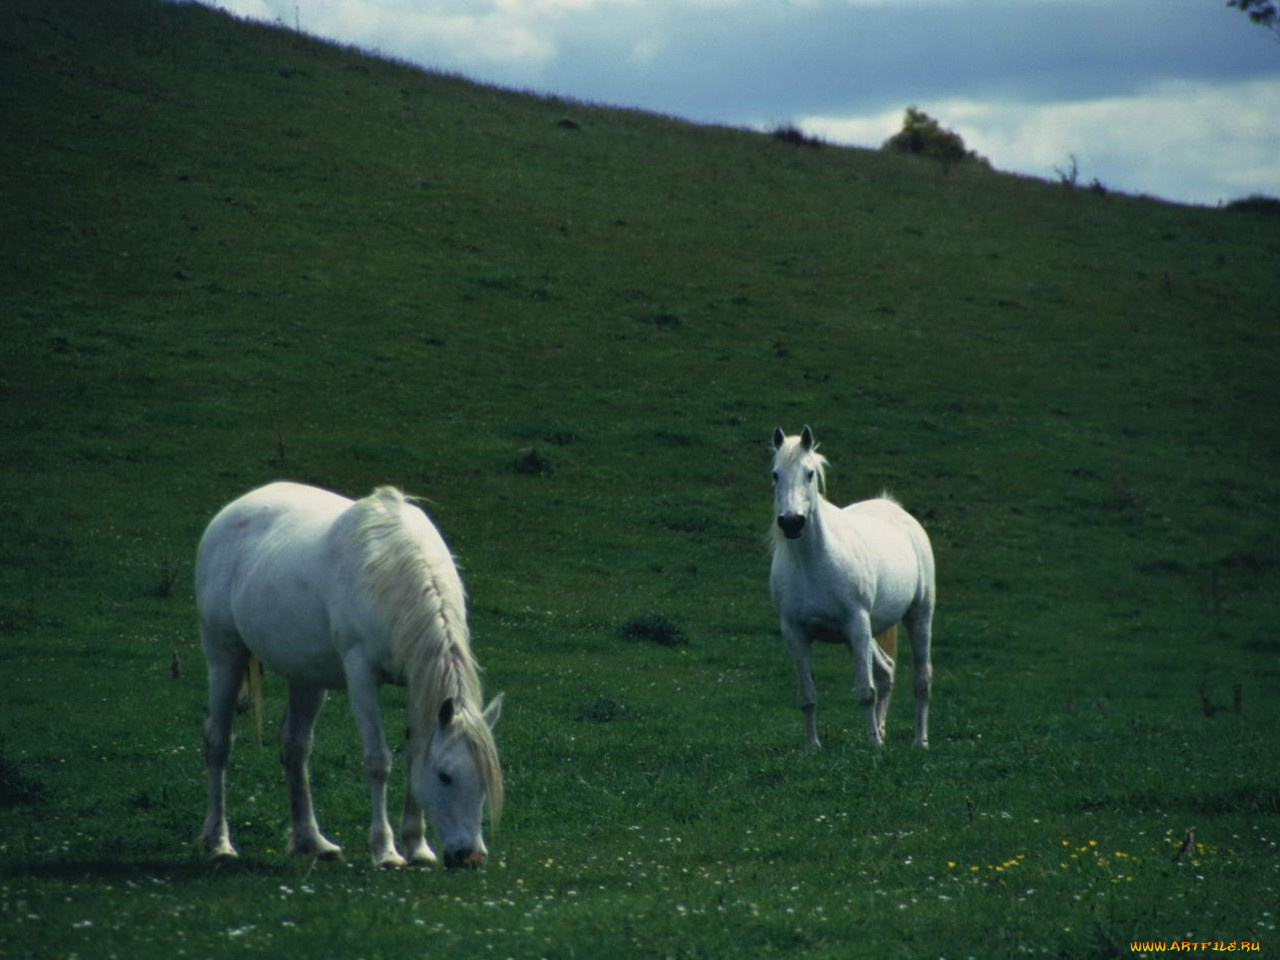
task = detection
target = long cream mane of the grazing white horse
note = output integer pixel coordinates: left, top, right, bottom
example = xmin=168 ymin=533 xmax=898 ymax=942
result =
xmin=353 ymin=486 xmax=503 ymax=823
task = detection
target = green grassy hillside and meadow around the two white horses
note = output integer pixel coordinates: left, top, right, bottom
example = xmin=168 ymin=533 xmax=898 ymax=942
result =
xmin=0 ymin=0 xmax=1280 ymax=957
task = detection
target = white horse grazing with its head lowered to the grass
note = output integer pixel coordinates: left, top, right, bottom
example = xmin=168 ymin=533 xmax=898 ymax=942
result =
xmin=196 ymin=483 xmax=503 ymax=868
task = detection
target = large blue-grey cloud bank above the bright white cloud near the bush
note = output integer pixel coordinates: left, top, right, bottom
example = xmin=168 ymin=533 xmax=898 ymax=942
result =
xmin=209 ymin=0 xmax=1275 ymax=108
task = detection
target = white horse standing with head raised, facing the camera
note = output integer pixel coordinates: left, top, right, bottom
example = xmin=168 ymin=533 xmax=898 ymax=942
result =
xmin=769 ymin=426 xmax=934 ymax=748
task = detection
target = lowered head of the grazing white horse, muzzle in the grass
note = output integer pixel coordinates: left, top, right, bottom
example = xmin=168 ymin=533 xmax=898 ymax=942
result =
xmin=411 ymin=694 xmax=503 ymax=869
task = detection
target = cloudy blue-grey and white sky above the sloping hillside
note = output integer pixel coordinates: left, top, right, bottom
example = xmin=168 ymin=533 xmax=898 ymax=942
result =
xmin=192 ymin=0 xmax=1280 ymax=206
